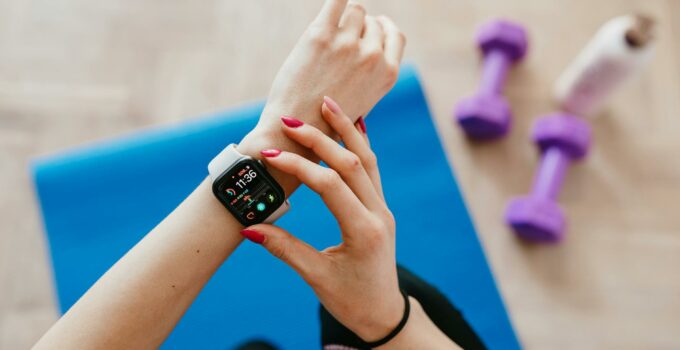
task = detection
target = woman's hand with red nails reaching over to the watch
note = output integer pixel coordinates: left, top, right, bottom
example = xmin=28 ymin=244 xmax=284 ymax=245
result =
xmin=242 ymin=98 xmax=404 ymax=341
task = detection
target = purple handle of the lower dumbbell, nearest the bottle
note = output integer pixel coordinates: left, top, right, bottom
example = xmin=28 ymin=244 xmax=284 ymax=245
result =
xmin=531 ymin=147 xmax=571 ymax=200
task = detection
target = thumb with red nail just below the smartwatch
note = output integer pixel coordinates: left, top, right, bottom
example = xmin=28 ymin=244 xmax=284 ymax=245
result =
xmin=241 ymin=224 xmax=325 ymax=279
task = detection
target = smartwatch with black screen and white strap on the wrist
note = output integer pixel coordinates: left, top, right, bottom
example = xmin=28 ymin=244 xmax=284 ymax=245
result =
xmin=208 ymin=144 xmax=290 ymax=226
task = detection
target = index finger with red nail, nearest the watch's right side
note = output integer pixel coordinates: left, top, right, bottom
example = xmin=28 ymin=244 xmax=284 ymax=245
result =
xmin=262 ymin=150 xmax=368 ymax=228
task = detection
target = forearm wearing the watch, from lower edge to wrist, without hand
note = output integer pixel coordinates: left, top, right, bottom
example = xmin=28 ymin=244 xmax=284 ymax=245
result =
xmin=36 ymin=119 xmax=332 ymax=348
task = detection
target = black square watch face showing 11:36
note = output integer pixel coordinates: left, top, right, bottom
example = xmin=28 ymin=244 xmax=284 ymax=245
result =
xmin=213 ymin=159 xmax=285 ymax=226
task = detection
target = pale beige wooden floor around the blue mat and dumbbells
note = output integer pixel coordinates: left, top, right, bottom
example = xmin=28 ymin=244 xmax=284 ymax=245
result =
xmin=0 ymin=0 xmax=680 ymax=349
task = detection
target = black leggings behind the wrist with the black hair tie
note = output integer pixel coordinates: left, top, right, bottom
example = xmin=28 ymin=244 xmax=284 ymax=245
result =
xmin=319 ymin=266 xmax=486 ymax=350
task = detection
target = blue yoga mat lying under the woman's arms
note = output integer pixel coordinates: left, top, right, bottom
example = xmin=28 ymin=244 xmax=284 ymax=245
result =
xmin=33 ymin=66 xmax=519 ymax=349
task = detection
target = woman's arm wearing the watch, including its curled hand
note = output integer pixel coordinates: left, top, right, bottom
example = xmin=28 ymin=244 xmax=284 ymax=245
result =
xmin=35 ymin=0 xmax=403 ymax=349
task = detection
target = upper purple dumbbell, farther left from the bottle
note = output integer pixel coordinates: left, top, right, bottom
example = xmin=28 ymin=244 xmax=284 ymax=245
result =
xmin=454 ymin=20 xmax=528 ymax=139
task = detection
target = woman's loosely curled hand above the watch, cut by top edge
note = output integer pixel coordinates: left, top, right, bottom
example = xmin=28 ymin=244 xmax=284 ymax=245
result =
xmin=260 ymin=0 xmax=406 ymax=131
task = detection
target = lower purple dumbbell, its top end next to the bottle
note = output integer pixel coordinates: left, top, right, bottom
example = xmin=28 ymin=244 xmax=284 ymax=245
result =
xmin=505 ymin=113 xmax=590 ymax=242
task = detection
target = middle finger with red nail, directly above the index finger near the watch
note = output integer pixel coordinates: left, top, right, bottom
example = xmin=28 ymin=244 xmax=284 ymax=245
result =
xmin=281 ymin=117 xmax=384 ymax=211
